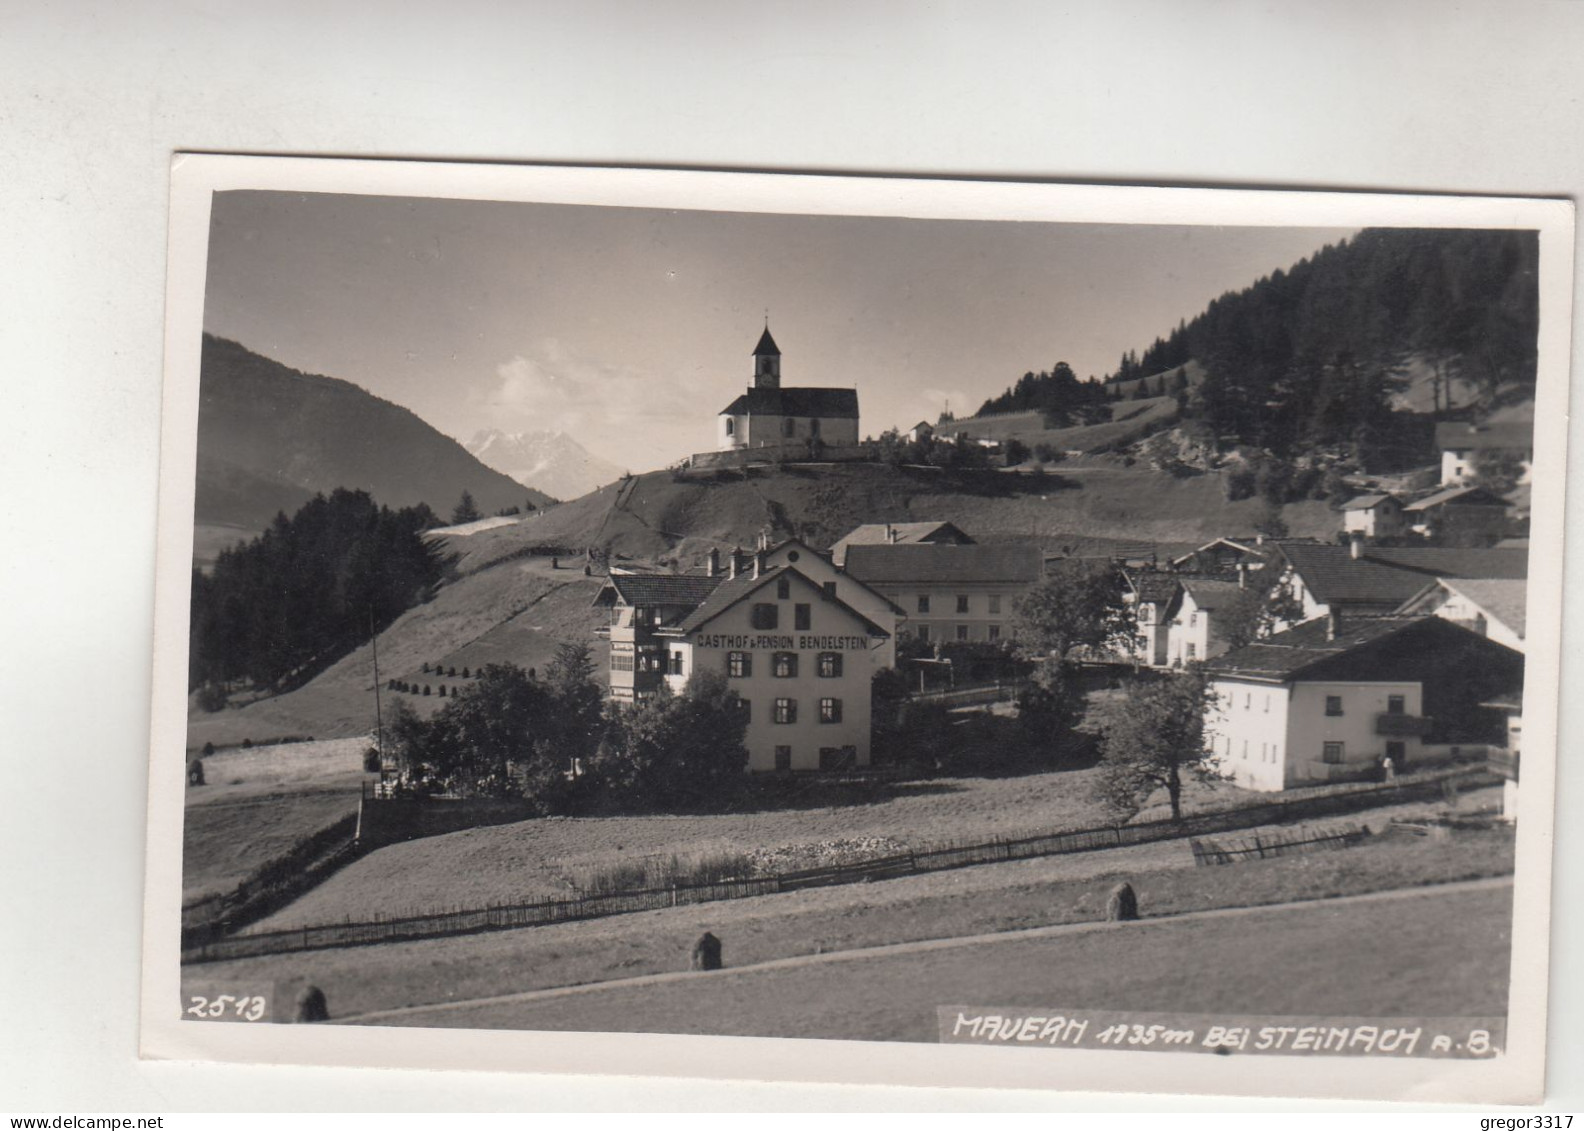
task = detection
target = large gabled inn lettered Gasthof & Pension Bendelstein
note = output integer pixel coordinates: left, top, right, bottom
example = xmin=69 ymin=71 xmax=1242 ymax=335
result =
xmin=596 ymin=546 xmax=890 ymax=771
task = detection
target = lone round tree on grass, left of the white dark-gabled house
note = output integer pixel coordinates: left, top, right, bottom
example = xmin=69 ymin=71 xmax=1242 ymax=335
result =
xmin=1095 ymin=670 xmax=1218 ymax=821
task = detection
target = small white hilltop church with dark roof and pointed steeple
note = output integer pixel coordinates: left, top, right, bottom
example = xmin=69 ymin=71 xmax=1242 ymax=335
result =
xmin=716 ymin=322 xmax=859 ymax=455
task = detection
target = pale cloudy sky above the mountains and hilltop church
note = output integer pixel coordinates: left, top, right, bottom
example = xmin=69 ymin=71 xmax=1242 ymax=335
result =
xmin=204 ymin=192 xmax=1351 ymax=472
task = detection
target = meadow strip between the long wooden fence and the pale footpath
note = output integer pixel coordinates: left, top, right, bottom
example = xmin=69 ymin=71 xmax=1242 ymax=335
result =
xmin=182 ymin=830 xmax=1513 ymax=1023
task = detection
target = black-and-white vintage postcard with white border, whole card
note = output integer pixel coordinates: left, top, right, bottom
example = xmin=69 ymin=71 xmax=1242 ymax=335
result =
xmin=143 ymin=155 xmax=1573 ymax=1102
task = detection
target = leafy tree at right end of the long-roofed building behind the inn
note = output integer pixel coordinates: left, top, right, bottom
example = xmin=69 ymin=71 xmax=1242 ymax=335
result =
xmin=1012 ymin=561 xmax=1134 ymax=662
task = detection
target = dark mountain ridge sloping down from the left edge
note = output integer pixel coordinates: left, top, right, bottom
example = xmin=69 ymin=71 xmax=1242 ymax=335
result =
xmin=195 ymin=334 xmax=553 ymax=529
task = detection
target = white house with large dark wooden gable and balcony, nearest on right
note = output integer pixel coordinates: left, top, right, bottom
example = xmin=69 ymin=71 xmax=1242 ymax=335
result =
xmin=1205 ymin=615 xmax=1524 ymax=790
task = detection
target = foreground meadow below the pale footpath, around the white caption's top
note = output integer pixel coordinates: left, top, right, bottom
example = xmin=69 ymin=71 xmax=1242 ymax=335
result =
xmin=371 ymin=887 xmax=1511 ymax=1042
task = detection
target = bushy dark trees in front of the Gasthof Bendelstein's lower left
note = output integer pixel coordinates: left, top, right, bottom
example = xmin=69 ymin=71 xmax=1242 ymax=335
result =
xmin=386 ymin=645 xmax=748 ymax=814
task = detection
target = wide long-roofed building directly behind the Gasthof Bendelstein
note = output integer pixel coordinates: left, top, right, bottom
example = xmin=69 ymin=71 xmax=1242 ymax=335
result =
xmin=844 ymin=542 xmax=1044 ymax=643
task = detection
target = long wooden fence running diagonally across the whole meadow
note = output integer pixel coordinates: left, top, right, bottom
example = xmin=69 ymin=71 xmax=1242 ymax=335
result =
xmin=182 ymin=767 xmax=1491 ymax=963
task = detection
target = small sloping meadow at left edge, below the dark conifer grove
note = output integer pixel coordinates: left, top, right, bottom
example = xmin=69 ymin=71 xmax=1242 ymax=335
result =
xmin=182 ymin=738 xmax=367 ymax=903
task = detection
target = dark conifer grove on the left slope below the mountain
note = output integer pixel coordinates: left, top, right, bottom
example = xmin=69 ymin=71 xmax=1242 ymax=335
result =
xmin=188 ymin=489 xmax=450 ymax=690
